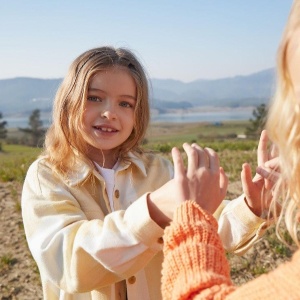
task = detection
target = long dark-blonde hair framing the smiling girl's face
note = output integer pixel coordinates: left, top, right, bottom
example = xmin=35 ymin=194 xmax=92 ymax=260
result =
xmin=42 ymin=47 xmax=150 ymax=175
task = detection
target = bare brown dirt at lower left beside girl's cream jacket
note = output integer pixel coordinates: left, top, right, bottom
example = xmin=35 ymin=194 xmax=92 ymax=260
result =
xmin=0 ymin=182 xmax=43 ymax=300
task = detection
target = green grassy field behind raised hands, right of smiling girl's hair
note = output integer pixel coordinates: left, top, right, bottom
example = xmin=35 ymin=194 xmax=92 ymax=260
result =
xmin=144 ymin=121 xmax=258 ymax=181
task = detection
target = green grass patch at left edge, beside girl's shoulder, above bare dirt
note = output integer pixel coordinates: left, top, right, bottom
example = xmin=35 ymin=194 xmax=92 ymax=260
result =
xmin=0 ymin=144 xmax=41 ymax=183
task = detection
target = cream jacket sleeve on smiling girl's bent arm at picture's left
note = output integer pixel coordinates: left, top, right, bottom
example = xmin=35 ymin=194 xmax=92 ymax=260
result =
xmin=22 ymin=159 xmax=163 ymax=293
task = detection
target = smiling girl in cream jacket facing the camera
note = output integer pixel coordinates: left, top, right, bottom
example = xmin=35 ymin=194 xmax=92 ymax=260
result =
xmin=22 ymin=47 xmax=272 ymax=300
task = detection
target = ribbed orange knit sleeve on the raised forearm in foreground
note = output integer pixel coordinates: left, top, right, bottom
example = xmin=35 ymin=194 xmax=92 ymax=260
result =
xmin=162 ymin=201 xmax=235 ymax=300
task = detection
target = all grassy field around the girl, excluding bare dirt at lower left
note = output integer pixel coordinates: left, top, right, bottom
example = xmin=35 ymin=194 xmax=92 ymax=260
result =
xmin=0 ymin=122 xmax=291 ymax=296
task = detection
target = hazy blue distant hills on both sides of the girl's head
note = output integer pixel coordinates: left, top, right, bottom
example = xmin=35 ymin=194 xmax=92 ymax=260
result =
xmin=0 ymin=69 xmax=275 ymax=116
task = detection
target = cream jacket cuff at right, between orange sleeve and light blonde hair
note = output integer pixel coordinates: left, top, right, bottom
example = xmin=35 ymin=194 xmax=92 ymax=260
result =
xmin=214 ymin=195 xmax=270 ymax=255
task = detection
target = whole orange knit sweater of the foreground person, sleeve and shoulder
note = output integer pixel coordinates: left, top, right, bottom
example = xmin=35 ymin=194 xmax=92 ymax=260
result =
xmin=162 ymin=201 xmax=300 ymax=300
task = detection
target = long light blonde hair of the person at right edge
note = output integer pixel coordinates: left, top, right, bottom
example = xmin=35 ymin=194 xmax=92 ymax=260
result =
xmin=266 ymin=0 xmax=300 ymax=246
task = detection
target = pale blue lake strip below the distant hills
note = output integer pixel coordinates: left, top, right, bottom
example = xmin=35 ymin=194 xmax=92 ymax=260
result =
xmin=3 ymin=107 xmax=253 ymax=128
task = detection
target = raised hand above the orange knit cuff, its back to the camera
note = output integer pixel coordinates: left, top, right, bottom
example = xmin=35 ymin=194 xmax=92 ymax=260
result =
xmin=172 ymin=143 xmax=228 ymax=213
